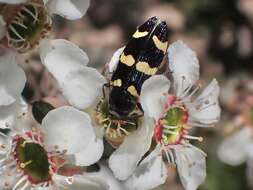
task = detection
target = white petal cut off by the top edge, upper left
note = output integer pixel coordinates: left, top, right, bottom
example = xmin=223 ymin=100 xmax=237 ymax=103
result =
xmin=47 ymin=0 xmax=90 ymax=20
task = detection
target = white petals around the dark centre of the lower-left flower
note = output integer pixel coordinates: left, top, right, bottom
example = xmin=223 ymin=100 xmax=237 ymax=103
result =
xmin=0 ymin=54 xmax=109 ymax=190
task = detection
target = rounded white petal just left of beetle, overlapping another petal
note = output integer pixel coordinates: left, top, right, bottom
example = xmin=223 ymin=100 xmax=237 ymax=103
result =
xmin=61 ymin=67 xmax=106 ymax=109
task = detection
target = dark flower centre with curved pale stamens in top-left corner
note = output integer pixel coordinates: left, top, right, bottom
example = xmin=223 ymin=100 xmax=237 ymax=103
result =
xmin=1 ymin=0 xmax=51 ymax=53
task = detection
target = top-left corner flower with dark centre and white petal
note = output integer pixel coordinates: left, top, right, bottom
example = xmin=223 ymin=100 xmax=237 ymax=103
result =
xmin=0 ymin=0 xmax=90 ymax=53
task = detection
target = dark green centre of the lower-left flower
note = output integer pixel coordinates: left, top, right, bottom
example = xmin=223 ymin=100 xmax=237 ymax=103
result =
xmin=14 ymin=137 xmax=51 ymax=184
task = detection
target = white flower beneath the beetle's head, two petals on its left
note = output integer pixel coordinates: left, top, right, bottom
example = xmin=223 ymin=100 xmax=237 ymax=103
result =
xmin=41 ymin=39 xmax=147 ymax=141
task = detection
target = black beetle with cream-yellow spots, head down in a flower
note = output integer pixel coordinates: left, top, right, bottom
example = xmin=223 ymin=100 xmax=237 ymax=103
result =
xmin=109 ymin=17 xmax=169 ymax=118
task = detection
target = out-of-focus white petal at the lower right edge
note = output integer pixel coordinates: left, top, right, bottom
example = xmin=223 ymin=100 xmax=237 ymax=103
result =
xmin=218 ymin=127 xmax=253 ymax=166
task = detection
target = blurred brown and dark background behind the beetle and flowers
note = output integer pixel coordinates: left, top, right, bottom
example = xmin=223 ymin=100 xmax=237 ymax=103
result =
xmin=23 ymin=0 xmax=253 ymax=190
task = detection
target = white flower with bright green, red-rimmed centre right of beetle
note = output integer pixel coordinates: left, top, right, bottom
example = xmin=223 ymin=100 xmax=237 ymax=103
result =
xmin=109 ymin=41 xmax=220 ymax=190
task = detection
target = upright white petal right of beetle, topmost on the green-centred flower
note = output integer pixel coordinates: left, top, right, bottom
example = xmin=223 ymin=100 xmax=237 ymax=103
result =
xmin=168 ymin=41 xmax=199 ymax=97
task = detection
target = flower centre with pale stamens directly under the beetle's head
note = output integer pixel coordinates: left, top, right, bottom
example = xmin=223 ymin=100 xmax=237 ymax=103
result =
xmin=95 ymin=99 xmax=142 ymax=145
